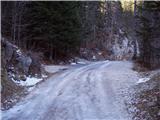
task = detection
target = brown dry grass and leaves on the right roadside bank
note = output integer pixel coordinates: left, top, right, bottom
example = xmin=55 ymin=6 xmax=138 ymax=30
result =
xmin=132 ymin=74 xmax=160 ymax=120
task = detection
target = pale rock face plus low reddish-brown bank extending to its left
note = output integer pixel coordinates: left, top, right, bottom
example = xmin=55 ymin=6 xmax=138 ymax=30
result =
xmin=80 ymin=29 xmax=139 ymax=60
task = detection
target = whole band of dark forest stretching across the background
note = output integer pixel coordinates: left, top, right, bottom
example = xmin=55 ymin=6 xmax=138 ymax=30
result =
xmin=1 ymin=0 xmax=160 ymax=68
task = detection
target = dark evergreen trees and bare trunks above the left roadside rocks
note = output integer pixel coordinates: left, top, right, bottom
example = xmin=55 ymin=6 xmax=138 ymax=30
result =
xmin=2 ymin=1 xmax=81 ymax=60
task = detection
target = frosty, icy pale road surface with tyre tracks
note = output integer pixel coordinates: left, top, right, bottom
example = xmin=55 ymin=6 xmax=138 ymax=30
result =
xmin=2 ymin=61 xmax=138 ymax=120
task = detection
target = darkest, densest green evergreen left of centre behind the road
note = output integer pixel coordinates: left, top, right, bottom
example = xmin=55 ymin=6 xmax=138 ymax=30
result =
xmin=28 ymin=2 xmax=80 ymax=59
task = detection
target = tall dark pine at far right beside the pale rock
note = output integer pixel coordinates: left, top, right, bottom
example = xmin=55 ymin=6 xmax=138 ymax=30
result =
xmin=137 ymin=1 xmax=160 ymax=68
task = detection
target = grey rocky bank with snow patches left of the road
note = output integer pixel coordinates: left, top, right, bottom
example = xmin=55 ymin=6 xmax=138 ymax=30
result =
xmin=1 ymin=38 xmax=41 ymax=109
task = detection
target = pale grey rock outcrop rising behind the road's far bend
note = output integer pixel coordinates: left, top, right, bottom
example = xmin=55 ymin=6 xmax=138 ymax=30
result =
xmin=109 ymin=29 xmax=139 ymax=60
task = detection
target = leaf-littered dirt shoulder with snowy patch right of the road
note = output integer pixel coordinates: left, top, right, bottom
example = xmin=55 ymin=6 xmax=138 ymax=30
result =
xmin=128 ymin=70 xmax=160 ymax=120
